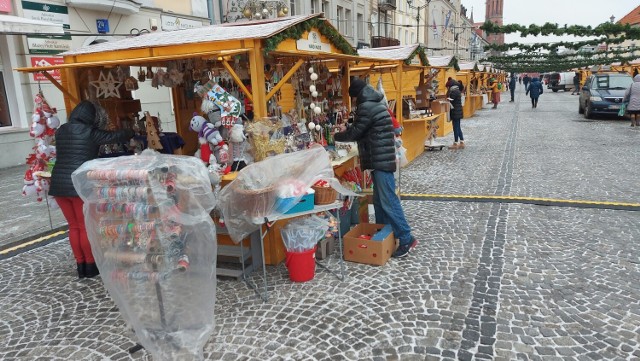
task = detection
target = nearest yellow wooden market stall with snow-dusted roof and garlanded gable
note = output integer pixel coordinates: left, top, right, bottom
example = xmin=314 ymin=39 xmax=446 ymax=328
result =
xmin=17 ymin=14 xmax=380 ymax=264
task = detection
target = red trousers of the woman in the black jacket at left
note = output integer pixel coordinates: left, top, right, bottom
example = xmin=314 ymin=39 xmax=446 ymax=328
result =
xmin=55 ymin=197 xmax=95 ymax=263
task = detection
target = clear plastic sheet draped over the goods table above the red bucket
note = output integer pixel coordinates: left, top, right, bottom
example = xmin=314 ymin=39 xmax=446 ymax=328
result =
xmin=220 ymin=145 xmax=357 ymax=243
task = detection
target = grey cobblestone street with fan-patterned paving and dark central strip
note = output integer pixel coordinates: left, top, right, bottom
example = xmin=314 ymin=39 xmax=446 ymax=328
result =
xmin=0 ymin=86 xmax=640 ymax=361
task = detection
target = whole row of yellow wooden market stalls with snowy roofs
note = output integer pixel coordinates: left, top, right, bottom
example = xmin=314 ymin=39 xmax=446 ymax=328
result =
xmin=18 ymin=14 xmax=505 ymax=165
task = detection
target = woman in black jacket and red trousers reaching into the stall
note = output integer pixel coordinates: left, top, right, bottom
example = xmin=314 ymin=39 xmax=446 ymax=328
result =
xmin=49 ymin=100 xmax=133 ymax=278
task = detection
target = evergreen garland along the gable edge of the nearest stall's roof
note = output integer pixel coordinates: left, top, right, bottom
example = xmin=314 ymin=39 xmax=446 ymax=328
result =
xmin=264 ymin=18 xmax=358 ymax=55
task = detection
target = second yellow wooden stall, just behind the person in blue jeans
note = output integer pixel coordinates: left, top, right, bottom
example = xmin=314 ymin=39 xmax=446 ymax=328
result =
xmin=351 ymin=44 xmax=442 ymax=162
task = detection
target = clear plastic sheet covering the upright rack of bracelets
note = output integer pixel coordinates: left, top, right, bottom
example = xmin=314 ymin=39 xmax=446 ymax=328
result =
xmin=72 ymin=150 xmax=217 ymax=360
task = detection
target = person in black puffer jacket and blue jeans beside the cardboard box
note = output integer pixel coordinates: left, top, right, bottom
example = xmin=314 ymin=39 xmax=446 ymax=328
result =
xmin=334 ymin=79 xmax=418 ymax=257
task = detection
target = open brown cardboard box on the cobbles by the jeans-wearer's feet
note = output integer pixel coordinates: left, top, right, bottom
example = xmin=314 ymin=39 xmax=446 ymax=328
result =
xmin=343 ymin=223 xmax=396 ymax=266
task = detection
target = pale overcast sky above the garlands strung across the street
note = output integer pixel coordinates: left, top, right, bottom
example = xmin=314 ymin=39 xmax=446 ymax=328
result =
xmin=462 ymin=0 xmax=638 ymax=43
